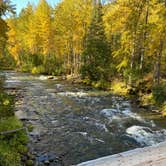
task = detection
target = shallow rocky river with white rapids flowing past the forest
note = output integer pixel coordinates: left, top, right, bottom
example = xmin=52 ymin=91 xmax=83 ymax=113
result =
xmin=1 ymin=71 xmax=166 ymax=166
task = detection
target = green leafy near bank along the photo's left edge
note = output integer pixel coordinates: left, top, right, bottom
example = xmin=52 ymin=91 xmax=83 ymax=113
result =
xmin=0 ymin=77 xmax=28 ymax=166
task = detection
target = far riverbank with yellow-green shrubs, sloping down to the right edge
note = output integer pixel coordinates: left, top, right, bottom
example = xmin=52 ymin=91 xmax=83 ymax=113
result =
xmin=76 ymin=77 xmax=166 ymax=117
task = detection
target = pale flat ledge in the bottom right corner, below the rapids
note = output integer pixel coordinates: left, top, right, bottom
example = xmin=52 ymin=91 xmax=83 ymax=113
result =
xmin=77 ymin=142 xmax=166 ymax=166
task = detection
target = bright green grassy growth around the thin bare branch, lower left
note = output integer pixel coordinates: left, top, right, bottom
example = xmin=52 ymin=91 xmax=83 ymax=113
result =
xmin=0 ymin=116 xmax=28 ymax=166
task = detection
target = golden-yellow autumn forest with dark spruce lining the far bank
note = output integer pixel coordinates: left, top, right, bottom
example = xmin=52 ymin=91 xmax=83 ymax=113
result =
xmin=0 ymin=0 xmax=166 ymax=109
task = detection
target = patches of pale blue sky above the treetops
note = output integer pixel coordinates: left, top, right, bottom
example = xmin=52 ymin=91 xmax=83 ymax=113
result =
xmin=11 ymin=0 xmax=60 ymax=14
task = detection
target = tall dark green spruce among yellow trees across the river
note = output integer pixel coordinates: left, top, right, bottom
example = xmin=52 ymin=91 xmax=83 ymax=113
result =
xmin=81 ymin=0 xmax=111 ymax=81
